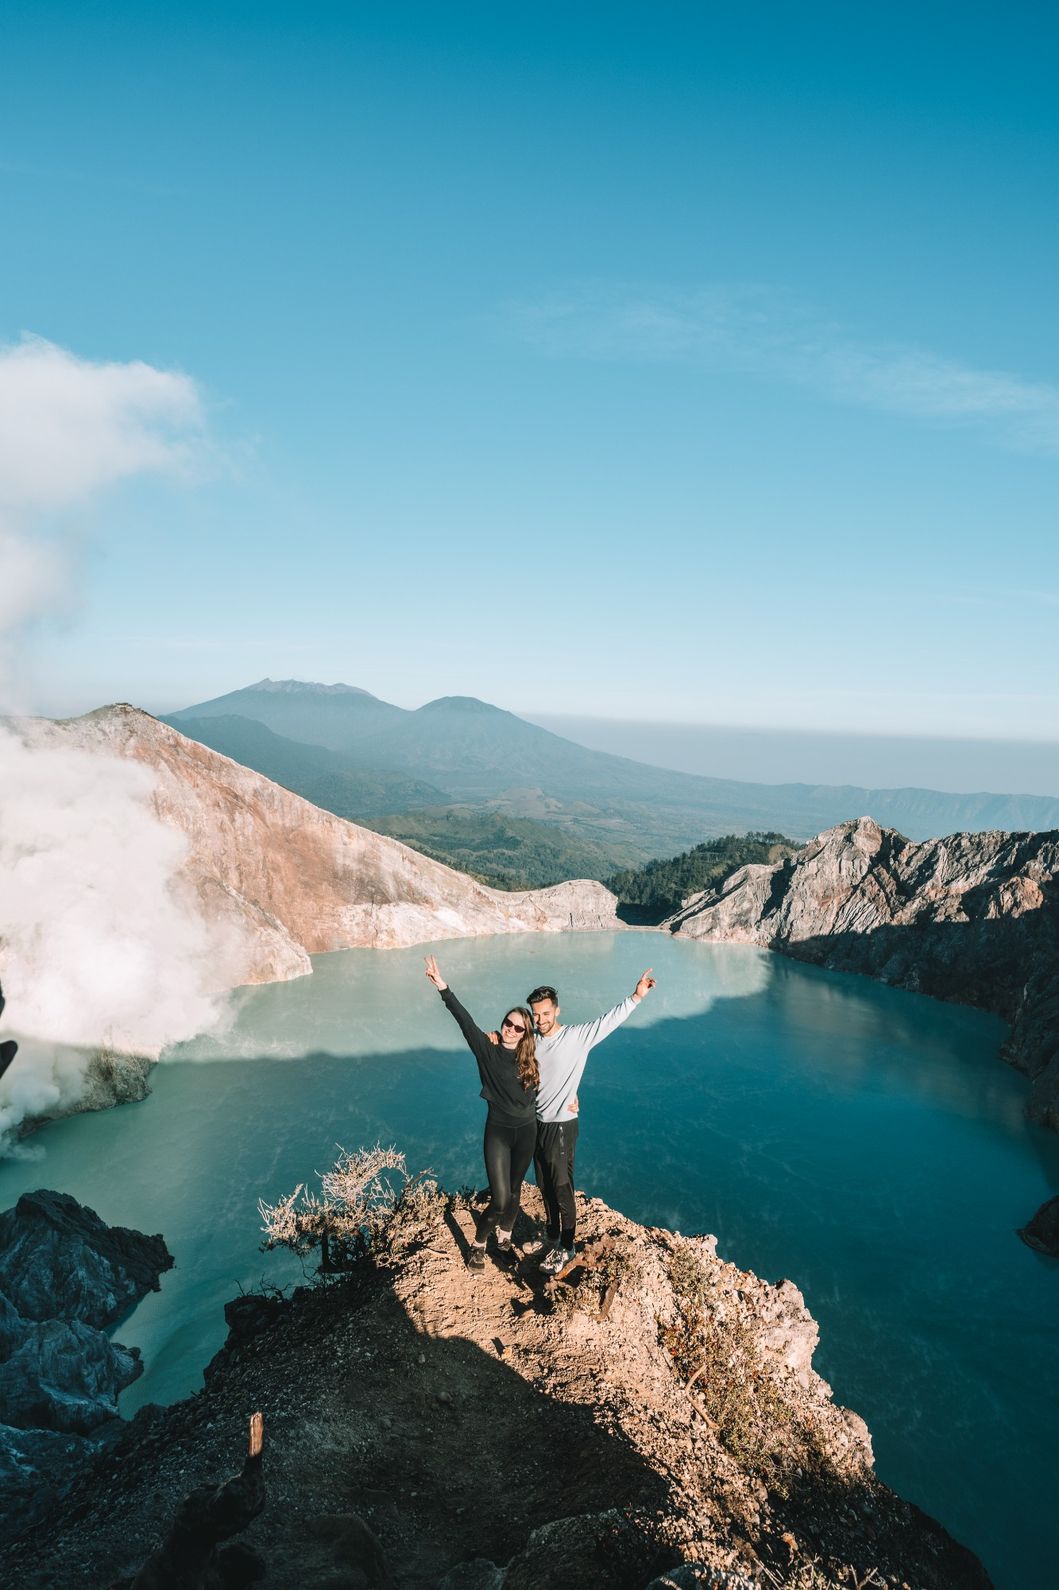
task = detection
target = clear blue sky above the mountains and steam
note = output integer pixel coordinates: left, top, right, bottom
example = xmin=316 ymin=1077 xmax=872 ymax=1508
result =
xmin=0 ymin=0 xmax=1059 ymax=750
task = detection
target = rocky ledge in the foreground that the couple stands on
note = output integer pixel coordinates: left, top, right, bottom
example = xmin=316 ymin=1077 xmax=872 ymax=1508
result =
xmin=0 ymin=1186 xmax=987 ymax=1590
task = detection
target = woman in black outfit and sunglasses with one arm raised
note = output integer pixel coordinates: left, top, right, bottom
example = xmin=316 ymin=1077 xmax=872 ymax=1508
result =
xmin=426 ymin=956 xmax=541 ymax=1270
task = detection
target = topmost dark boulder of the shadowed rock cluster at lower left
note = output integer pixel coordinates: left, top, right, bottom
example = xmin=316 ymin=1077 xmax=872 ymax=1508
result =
xmin=0 ymin=1189 xmax=173 ymax=1329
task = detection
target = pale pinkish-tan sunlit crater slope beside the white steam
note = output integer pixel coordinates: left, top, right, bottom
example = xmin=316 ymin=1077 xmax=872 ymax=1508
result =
xmin=31 ymin=706 xmax=620 ymax=983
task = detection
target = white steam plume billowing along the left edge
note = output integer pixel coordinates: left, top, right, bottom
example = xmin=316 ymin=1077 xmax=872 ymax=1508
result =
xmin=0 ymin=339 xmax=240 ymax=1153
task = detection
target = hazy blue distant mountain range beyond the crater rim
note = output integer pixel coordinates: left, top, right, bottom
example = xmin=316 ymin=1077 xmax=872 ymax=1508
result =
xmin=167 ymin=679 xmax=1059 ymax=857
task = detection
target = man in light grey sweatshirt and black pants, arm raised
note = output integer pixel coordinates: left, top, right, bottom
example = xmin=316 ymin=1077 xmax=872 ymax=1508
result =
xmin=526 ymin=967 xmax=655 ymax=1275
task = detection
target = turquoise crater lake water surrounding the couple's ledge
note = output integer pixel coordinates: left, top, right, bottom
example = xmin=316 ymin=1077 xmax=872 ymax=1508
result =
xmin=0 ymin=932 xmax=1059 ymax=1590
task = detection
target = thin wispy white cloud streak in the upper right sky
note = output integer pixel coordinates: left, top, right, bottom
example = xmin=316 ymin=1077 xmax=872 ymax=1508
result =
xmin=504 ymin=285 xmax=1059 ymax=455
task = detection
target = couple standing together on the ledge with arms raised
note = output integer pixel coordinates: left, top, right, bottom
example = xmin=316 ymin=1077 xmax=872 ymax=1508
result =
xmin=426 ymin=956 xmax=655 ymax=1275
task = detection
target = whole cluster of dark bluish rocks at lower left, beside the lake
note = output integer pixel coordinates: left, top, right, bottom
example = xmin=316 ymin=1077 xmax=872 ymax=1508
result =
xmin=0 ymin=1191 xmax=173 ymax=1528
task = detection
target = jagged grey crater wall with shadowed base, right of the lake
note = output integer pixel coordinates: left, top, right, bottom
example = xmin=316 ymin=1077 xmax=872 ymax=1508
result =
xmin=663 ymin=817 xmax=1059 ymax=1129
